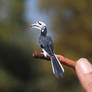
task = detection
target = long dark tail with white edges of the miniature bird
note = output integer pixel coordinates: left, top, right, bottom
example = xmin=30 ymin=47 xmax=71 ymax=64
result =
xmin=51 ymin=55 xmax=64 ymax=78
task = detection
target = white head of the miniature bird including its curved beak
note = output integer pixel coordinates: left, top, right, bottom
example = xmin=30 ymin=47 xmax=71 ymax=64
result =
xmin=30 ymin=21 xmax=46 ymax=32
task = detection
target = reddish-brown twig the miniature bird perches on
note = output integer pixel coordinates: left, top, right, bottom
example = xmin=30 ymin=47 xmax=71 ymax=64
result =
xmin=33 ymin=51 xmax=76 ymax=70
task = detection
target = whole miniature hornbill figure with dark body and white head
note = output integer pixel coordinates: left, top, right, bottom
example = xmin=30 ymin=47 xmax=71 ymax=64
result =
xmin=31 ymin=21 xmax=64 ymax=78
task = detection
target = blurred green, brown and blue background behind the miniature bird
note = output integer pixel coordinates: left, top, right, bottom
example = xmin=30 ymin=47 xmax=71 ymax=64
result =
xmin=0 ymin=0 xmax=92 ymax=92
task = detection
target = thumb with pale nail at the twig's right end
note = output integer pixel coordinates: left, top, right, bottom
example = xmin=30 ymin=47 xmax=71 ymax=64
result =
xmin=75 ymin=58 xmax=92 ymax=92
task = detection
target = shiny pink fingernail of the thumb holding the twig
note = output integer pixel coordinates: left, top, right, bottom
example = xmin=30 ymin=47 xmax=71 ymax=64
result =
xmin=77 ymin=58 xmax=92 ymax=74
